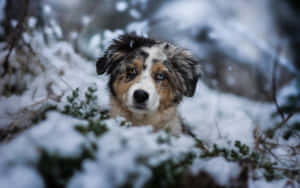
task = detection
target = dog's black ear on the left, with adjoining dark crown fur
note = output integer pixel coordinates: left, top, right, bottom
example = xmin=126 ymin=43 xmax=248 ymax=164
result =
xmin=96 ymin=34 xmax=157 ymax=74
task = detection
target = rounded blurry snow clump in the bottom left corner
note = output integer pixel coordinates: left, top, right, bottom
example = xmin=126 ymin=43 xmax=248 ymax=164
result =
xmin=0 ymin=133 xmax=43 ymax=188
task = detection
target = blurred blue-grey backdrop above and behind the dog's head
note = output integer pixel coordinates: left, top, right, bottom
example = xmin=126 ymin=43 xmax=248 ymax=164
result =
xmin=0 ymin=0 xmax=300 ymax=101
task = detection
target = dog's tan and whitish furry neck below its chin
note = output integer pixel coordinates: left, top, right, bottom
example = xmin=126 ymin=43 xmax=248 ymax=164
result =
xmin=110 ymin=97 xmax=182 ymax=135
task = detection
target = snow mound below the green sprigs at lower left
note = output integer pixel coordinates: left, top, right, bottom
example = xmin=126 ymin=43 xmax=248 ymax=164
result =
xmin=0 ymin=112 xmax=87 ymax=164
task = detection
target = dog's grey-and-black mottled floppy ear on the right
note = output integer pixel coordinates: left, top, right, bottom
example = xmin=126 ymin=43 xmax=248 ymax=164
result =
xmin=171 ymin=49 xmax=202 ymax=97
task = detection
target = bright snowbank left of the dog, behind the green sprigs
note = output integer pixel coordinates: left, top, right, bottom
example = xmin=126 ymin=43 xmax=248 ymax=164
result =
xmin=0 ymin=33 xmax=108 ymax=127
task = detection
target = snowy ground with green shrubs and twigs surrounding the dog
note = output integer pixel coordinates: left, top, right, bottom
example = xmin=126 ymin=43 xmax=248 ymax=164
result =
xmin=0 ymin=1 xmax=300 ymax=188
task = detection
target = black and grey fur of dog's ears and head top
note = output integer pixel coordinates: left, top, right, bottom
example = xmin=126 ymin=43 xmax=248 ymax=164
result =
xmin=96 ymin=34 xmax=200 ymax=99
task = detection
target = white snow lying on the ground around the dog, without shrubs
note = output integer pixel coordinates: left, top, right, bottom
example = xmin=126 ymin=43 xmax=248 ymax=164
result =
xmin=0 ymin=0 xmax=300 ymax=188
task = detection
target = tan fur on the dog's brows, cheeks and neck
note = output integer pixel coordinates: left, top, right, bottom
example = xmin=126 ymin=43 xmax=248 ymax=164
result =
xmin=111 ymin=59 xmax=180 ymax=132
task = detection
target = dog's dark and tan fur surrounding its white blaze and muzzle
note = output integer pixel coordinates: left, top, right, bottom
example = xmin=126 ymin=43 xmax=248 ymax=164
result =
xmin=96 ymin=34 xmax=201 ymax=134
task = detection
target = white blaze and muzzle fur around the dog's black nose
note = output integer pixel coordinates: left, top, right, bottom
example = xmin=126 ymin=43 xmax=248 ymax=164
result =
xmin=127 ymin=46 xmax=167 ymax=114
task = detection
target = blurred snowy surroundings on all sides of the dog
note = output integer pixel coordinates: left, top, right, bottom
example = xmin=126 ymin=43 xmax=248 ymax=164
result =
xmin=0 ymin=0 xmax=300 ymax=188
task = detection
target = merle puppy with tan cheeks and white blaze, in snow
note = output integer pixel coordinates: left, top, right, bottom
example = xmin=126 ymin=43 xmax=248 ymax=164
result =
xmin=96 ymin=34 xmax=202 ymax=135
